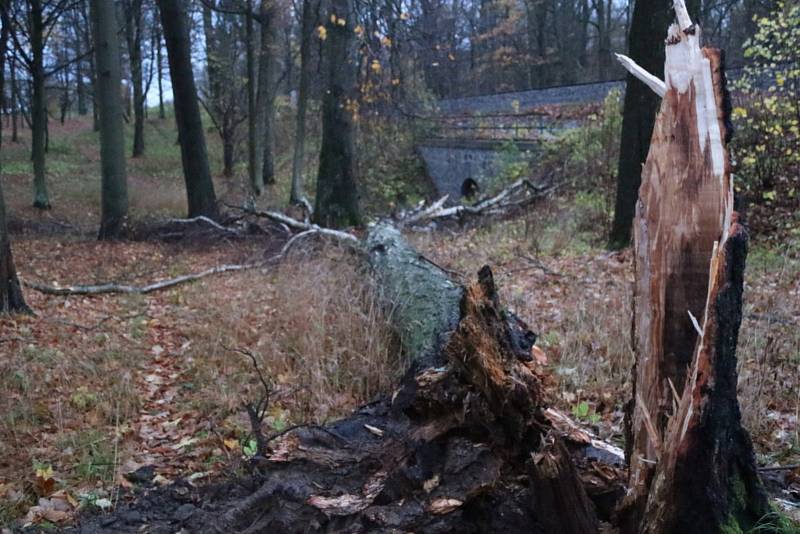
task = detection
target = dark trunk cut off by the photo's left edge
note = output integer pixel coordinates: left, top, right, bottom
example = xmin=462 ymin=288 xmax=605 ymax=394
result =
xmin=0 ymin=0 xmax=30 ymax=313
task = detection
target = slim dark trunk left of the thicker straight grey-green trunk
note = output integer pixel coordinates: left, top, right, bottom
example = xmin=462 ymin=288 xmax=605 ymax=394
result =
xmin=30 ymin=0 xmax=50 ymax=209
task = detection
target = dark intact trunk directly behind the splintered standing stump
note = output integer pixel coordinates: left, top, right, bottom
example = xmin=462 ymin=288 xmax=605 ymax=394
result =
xmin=609 ymin=0 xmax=672 ymax=249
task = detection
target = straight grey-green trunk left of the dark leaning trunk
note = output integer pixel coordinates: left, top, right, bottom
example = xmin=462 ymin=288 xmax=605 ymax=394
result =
xmin=90 ymin=0 xmax=128 ymax=239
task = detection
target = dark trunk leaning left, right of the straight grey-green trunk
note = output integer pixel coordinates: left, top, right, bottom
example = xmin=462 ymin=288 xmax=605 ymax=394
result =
xmin=158 ymin=0 xmax=218 ymax=218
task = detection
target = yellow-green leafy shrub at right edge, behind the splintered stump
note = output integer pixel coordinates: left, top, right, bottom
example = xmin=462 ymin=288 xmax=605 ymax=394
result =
xmin=731 ymin=2 xmax=800 ymax=243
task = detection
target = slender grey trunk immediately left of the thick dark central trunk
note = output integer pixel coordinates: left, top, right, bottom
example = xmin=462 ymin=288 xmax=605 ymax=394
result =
xmin=289 ymin=0 xmax=312 ymax=204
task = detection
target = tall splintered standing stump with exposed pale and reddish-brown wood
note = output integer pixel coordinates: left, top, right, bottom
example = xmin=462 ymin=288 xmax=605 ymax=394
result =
xmin=622 ymin=0 xmax=769 ymax=533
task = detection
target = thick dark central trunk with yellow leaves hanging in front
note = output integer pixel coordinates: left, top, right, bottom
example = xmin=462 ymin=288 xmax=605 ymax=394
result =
xmin=314 ymin=0 xmax=361 ymax=227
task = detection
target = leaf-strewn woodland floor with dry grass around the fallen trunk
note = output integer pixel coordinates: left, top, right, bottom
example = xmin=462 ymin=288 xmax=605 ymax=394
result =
xmin=0 ymin=115 xmax=800 ymax=525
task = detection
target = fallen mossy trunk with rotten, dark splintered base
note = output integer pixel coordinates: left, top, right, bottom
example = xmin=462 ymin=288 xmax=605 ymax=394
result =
xmin=202 ymin=226 xmax=598 ymax=534
